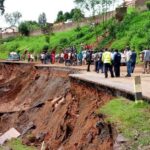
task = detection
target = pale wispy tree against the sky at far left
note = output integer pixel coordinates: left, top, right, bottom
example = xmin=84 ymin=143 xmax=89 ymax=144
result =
xmin=4 ymin=11 xmax=22 ymax=26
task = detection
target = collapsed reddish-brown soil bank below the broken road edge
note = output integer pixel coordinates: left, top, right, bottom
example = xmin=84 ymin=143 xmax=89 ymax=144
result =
xmin=0 ymin=64 xmax=113 ymax=150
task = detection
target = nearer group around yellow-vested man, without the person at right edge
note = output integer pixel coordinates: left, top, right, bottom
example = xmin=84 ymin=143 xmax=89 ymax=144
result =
xmin=84 ymin=48 xmax=137 ymax=78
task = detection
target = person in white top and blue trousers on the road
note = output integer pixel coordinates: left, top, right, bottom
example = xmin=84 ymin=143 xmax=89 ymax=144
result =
xmin=125 ymin=48 xmax=132 ymax=77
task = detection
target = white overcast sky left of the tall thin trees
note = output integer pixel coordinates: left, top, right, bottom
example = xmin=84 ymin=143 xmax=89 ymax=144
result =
xmin=0 ymin=0 xmax=75 ymax=27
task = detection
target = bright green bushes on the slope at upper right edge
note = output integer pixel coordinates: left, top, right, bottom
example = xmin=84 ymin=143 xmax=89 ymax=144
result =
xmin=111 ymin=11 xmax=150 ymax=51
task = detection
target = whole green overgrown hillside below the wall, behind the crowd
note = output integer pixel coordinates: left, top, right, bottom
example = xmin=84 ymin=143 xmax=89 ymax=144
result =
xmin=0 ymin=11 xmax=150 ymax=58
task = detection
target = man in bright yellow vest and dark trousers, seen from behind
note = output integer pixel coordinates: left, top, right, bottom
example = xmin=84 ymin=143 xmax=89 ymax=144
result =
xmin=102 ymin=48 xmax=114 ymax=78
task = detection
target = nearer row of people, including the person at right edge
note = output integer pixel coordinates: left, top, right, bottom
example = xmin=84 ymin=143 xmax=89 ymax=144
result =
xmin=86 ymin=47 xmax=150 ymax=78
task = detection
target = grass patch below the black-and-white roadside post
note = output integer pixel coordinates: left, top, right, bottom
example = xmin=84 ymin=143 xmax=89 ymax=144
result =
xmin=98 ymin=98 xmax=150 ymax=149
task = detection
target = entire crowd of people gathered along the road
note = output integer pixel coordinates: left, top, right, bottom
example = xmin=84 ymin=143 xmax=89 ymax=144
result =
xmin=11 ymin=45 xmax=150 ymax=78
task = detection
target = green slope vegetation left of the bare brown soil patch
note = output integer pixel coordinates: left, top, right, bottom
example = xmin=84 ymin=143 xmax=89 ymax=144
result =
xmin=0 ymin=26 xmax=99 ymax=58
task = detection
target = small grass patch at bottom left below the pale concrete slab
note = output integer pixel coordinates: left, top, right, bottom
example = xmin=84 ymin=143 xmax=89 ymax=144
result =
xmin=0 ymin=139 xmax=36 ymax=150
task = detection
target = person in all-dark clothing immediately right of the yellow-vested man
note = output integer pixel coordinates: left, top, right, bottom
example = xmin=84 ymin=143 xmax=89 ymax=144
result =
xmin=114 ymin=49 xmax=121 ymax=77
